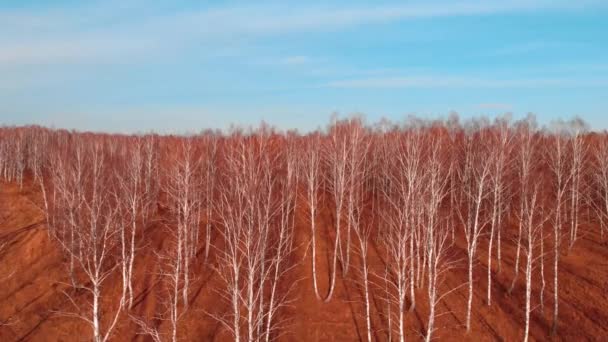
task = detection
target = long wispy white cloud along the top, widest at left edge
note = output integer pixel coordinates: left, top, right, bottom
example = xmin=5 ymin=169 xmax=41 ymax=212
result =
xmin=0 ymin=0 xmax=600 ymax=67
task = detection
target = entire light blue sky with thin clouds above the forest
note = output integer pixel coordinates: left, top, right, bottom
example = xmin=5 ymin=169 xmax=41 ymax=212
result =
xmin=0 ymin=0 xmax=608 ymax=133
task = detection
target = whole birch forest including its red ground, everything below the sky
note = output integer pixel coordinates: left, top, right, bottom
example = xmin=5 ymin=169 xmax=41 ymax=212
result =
xmin=0 ymin=115 xmax=608 ymax=342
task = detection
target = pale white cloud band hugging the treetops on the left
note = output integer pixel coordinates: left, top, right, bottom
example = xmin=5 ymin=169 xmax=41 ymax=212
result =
xmin=0 ymin=103 xmax=330 ymax=134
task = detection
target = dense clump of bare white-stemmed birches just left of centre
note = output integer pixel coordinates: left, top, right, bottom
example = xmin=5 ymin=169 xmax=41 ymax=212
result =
xmin=215 ymin=128 xmax=297 ymax=341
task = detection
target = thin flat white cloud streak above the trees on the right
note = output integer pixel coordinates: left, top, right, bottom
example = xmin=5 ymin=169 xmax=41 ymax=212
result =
xmin=324 ymin=76 xmax=608 ymax=89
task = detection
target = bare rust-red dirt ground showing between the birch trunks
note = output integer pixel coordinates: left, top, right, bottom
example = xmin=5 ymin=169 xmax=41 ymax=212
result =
xmin=0 ymin=183 xmax=608 ymax=341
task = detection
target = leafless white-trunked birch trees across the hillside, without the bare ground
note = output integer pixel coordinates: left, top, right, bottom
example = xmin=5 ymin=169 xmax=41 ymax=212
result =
xmin=0 ymin=117 xmax=608 ymax=341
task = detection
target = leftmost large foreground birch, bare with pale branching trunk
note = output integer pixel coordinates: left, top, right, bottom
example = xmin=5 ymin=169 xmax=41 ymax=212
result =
xmin=48 ymin=141 xmax=124 ymax=342
